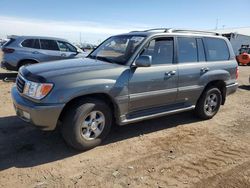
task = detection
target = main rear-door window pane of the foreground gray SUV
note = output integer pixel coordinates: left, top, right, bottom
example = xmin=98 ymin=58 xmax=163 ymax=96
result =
xmin=178 ymin=37 xmax=198 ymax=63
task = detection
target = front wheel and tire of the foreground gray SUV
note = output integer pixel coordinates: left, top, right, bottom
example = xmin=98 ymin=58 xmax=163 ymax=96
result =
xmin=61 ymin=98 xmax=112 ymax=151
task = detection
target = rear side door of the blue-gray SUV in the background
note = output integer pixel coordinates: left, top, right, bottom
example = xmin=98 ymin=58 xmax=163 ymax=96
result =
xmin=39 ymin=39 xmax=61 ymax=61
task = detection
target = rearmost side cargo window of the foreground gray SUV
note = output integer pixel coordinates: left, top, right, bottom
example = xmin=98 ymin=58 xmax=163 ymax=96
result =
xmin=206 ymin=38 xmax=229 ymax=61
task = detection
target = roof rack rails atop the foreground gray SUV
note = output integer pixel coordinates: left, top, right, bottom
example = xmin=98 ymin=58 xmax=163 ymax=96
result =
xmin=131 ymin=28 xmax=221 ymax=36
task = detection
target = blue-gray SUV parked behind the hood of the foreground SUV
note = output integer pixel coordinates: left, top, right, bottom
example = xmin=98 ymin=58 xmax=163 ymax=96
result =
xmin=1 ymin=36 xmax=87 ymax=71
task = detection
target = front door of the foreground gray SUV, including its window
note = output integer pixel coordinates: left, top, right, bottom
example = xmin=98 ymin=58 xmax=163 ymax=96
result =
xmin=129 ymin=37 xmax=178 ymax=112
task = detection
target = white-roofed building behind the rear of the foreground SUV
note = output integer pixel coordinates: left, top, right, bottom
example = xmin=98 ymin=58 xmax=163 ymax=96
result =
xmin=214 ymin=27 xmax=250 ymax=55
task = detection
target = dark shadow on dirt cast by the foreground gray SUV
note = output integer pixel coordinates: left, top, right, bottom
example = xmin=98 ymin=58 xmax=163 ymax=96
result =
xmin=0 ymin=112 xmax=199 ymax=170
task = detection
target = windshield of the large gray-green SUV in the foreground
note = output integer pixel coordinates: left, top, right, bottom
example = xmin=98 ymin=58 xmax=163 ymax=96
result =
xmin=88 ymin=35 xmax=145 ymax=65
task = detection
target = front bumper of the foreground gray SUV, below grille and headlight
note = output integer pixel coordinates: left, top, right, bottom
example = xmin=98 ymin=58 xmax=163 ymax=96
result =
xmin=11 ymin=86 xmax=64 ymax=130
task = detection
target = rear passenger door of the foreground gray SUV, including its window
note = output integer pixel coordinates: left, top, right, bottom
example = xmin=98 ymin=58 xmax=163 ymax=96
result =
xmin=177 ymin=36 xmax=209 ymax=106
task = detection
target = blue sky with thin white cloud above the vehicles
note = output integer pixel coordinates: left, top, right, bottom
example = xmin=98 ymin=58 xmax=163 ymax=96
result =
xmin=0 ymin=0 xmax=250 ymax=44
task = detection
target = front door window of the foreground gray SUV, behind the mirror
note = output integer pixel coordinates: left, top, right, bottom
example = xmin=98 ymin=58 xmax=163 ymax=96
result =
xmin=142 ymin=38 xmax=174 ymax=65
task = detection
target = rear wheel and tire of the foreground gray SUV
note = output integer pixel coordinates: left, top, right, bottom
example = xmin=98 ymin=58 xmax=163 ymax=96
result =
xmin=195 ymin=87 xmax=222 ymax=120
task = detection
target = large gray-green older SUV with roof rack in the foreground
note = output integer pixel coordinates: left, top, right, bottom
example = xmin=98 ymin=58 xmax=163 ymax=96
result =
xmin=12 ymin=29 xmax=238 ymax=150
